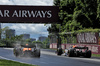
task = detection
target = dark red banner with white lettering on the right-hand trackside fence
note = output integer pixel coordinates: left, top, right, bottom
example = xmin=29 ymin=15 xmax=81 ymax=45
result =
xmin=77 ymin=32 xmax=99 ymax=44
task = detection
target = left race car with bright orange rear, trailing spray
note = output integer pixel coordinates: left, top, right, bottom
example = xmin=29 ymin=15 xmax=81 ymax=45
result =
xmin=13 ymin=44 xmax=40 ymax=57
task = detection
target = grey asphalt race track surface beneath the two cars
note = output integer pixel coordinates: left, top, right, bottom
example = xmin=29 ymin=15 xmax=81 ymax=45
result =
xmin=0 ymin=48 xmax=100 ymax=66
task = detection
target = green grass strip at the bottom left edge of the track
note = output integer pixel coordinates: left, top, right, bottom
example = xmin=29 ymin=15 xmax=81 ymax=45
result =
xmin=0 ymin=59 xmax=36 ymax=66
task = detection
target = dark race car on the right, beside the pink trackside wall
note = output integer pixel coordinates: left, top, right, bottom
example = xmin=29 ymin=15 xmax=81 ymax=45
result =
xmin=65 ymin=46 xmax=92 ymax=58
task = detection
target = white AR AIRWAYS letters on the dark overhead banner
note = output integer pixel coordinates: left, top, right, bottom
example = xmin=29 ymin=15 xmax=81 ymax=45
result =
xmin=11 ymin=10 xmax=52 ymax=18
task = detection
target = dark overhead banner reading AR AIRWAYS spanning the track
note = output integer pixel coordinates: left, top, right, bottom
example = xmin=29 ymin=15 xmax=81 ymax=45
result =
xmin=0 ymin=5 xmax=59 ymax=23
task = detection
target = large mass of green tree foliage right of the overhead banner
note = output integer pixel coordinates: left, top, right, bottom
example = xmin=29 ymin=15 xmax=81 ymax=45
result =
xmin=48 ymin=0 xmax=100 ymax=43
